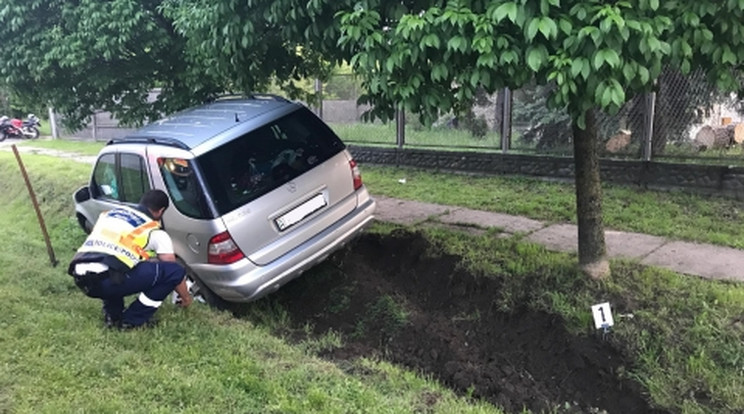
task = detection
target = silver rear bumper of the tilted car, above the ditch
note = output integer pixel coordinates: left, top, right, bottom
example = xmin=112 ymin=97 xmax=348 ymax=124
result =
xmin=191 ymin=198 xmax=377 ymax=302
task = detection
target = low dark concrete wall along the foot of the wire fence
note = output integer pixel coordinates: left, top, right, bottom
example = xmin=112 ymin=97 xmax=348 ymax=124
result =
xmin=349 ymin=145 xmax=744 ymax=199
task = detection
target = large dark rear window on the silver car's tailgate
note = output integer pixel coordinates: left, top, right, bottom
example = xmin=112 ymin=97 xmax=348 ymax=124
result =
xmin=197 ymin=108 xmax=345 ymax=214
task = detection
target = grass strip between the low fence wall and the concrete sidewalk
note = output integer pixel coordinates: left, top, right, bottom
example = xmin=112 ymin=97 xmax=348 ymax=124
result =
xmin=362 ymin=165 xmax=744 ymax=248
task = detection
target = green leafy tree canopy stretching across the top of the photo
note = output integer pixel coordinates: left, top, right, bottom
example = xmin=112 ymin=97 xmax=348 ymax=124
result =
xmin=5 ymin=0 xmax=744 ymax=141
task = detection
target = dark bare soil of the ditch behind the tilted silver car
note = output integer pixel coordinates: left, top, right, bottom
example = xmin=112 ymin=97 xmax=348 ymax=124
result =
xmin=241 ymin=232 xmax=662 ymax=414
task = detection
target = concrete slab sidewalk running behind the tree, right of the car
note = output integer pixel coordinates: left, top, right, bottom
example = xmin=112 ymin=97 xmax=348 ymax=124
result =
xmin=375 ymin=196 xmax=744 ymax=281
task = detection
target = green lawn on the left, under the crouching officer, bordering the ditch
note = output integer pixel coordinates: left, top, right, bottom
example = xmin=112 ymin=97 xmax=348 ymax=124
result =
xmin=0 ymin=152 xmax=499 ymax=413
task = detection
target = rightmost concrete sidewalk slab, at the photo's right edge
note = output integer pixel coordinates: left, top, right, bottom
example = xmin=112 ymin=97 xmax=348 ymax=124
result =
xmin=641 ymin=241 xmax=744 ymax=281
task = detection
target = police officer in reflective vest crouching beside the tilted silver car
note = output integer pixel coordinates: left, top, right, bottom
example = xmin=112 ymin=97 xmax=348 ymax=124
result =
xmin=67 ymin=190 xmax=192 ymax=329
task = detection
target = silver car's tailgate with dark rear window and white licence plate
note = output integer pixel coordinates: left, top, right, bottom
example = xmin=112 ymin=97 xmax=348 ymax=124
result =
xmin=198 ymin=108 xmax=356 ymax=265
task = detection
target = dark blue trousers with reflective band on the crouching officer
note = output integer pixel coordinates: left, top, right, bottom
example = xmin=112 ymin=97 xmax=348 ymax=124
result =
xmin=89 ymin=262 xmax=186 ymax=326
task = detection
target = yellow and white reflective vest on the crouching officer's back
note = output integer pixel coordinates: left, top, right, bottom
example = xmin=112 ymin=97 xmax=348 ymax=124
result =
xmin=77 ymin=208 xmax=160 ymax=269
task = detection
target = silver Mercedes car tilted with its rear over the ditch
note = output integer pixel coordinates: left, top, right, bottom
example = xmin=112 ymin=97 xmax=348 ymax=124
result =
xmin=73 ymin=95 xmax=375 ymax=303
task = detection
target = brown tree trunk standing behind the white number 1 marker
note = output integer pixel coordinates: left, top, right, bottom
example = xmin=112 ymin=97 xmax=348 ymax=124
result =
xmin=573 ymin=110 xmax=610 ymax=279
